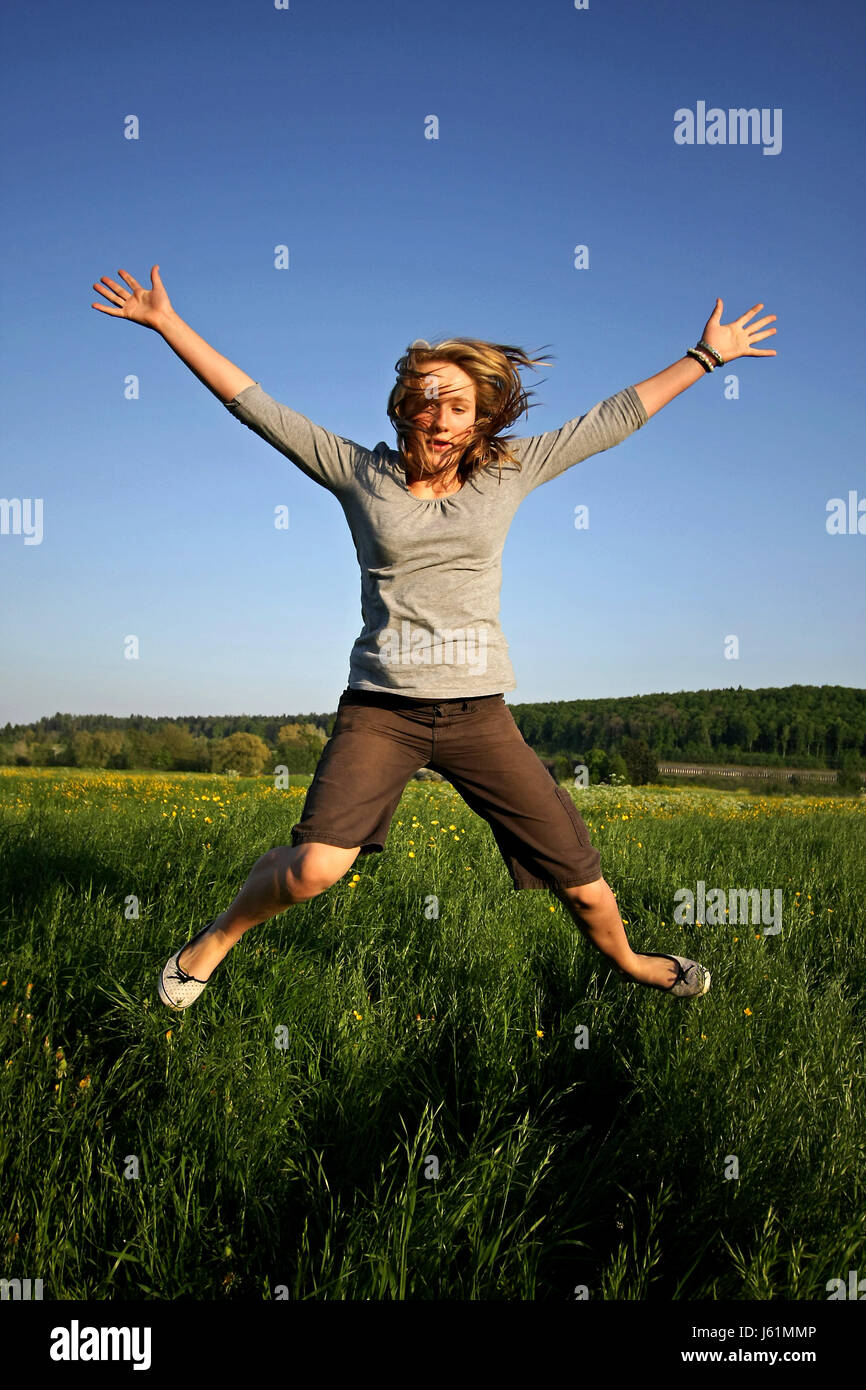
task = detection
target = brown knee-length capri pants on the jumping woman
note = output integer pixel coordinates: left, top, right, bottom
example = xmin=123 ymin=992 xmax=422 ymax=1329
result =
xmin=292 ymin=688 xmax=602 ymax=890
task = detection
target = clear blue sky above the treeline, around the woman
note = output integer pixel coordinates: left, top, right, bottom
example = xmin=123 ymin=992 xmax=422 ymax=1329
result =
xmin=0 ymin=0 xmax=866 ymax=723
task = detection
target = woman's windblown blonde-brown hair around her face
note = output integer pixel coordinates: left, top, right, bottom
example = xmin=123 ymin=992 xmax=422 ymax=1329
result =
xmin=388 ymin=338 xmax=548 ymax=482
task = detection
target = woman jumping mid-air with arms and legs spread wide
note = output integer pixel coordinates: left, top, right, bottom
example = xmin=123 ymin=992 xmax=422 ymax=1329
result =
xmin=92 ymin=265 xmax=776 ymax=1009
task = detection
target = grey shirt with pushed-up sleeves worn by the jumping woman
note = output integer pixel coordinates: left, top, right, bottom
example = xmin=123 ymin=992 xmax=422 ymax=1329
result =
xmin=225 ymin=382 xmax=649 ymax=701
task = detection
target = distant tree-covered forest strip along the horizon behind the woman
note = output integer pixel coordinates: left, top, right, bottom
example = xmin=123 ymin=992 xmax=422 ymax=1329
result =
xmin=0 ymin=685 xmax=866 ymax=781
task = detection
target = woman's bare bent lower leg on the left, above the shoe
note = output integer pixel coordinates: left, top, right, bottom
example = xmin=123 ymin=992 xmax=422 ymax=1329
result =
xmin=178 ymin=841 xmax=360 ymax=980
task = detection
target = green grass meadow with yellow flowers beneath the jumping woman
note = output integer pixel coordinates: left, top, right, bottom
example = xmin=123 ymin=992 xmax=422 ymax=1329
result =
xmin=0 ymin=769 xmax=866 ymax=1301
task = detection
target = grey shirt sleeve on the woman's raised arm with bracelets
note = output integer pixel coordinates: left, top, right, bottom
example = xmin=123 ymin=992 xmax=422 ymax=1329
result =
xmin=512 ymin=386 xmax=649 ymax=492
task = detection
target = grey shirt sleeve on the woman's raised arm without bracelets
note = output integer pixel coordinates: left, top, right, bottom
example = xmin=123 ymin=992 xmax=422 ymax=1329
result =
xmin=224 ymin=381 xmax=367 ymax=492
